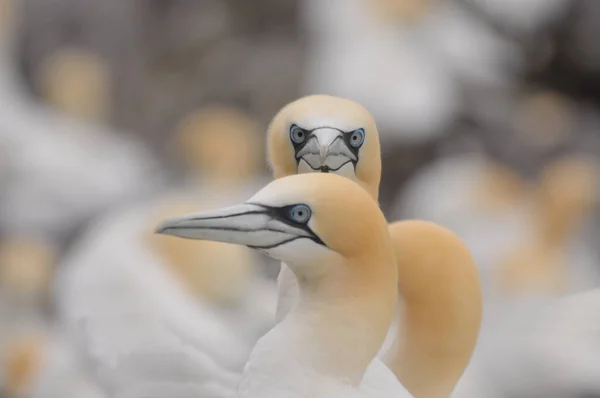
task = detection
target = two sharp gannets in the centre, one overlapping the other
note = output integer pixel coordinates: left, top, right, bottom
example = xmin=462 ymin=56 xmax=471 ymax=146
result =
xmin=157 ymin=95 xmax=482 ymax=398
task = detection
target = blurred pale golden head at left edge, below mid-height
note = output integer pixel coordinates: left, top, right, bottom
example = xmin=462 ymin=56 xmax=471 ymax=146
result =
xmin=0 ymin=238 xmax=57 ymax=299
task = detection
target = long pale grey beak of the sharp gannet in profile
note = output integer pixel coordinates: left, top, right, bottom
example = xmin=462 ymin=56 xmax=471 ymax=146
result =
xmin=155 ymin=203 xmax=315 ymax=250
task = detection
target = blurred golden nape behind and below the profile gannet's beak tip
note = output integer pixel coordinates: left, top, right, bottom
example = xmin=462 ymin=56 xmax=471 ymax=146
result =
xmin=146 ymin=202 xmax=255 ymax=305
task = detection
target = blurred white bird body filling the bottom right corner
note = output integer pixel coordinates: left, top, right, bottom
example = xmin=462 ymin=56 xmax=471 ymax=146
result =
xmin=453 ymin=289 xmax=600 ymax=398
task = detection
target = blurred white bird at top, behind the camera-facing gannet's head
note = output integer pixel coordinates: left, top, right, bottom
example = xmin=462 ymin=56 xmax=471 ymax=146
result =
xmin=302 ymin=0 xmax=518 ymax=144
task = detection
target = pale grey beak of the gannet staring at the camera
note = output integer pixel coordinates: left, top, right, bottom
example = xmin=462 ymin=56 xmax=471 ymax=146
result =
xmin=296 ymin=127 xmax=357 ymax=172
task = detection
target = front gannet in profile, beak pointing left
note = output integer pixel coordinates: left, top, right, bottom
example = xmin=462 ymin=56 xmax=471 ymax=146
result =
xmin=157 ymin=174 xmax=411 ymax=398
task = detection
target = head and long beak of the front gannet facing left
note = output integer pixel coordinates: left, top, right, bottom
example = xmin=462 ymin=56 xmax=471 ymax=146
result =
xmin=156 ymin=173 xmax=395 ymax=283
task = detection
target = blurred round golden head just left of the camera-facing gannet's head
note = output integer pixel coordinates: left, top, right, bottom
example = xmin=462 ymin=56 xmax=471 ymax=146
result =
xmin=175 ymin=106 xmax=263 ymax=184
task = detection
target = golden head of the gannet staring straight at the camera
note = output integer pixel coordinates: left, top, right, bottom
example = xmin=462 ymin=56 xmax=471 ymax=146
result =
xmin=267 ymin=95 xmax=381 ymax=198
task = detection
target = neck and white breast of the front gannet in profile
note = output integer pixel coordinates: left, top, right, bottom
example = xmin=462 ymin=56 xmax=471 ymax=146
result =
xmin=239 ymin=257 xmax=397 ymax=398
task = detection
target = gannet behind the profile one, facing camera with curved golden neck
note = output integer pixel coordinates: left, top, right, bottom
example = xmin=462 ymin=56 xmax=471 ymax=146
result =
xmin=268 ymin=95 xmax=482 ymax=397
